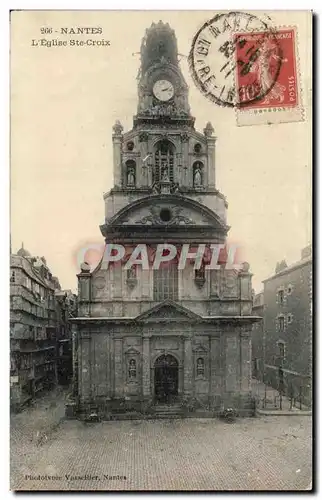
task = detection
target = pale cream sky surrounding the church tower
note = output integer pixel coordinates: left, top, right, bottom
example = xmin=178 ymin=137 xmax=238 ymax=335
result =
xmin=11 ymin=11 xmax=311 ymax=291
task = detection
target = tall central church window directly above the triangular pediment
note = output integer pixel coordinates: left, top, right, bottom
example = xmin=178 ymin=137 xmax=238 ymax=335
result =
xmin=153 ymin=264 xmax=178 ymax=301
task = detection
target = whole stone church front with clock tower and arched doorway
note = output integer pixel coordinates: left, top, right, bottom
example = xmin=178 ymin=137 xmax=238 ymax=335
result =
xmin=73 ymin=22 xmax=256 ymax=416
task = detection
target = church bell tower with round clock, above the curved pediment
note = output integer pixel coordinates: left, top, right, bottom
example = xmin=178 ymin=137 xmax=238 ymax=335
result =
xmin=104 ymin=21 xmax=225 ymax=223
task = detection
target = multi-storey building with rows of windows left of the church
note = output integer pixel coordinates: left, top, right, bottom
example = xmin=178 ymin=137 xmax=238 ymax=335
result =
xmin=10 ymin=245 xmax=75 ymax=409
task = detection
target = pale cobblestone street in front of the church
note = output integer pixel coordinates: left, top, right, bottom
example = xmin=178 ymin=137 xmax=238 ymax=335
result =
xmin=11 ymin=392 xmax=311 ymax=490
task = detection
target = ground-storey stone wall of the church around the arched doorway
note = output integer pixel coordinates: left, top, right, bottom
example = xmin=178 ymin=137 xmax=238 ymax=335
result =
xmin=79 ymin=323 xmax=251 ymax=416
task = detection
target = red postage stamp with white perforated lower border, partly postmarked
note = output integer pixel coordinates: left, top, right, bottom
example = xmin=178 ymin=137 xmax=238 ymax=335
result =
xmin=235 ymin=28 xmax=303 ymax=125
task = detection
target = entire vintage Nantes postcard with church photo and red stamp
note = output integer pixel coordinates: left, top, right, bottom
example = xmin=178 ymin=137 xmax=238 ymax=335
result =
xmin=10 ymin=10 xmax=313 ymax=492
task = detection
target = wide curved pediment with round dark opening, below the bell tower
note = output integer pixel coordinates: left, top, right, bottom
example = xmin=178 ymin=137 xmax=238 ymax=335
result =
xmin=109 ymin=195 xmax=228 ymax=232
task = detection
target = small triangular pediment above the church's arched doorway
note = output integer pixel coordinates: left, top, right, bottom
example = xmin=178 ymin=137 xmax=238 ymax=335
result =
xmin=135 ymin=300 xmax=202 ymax=322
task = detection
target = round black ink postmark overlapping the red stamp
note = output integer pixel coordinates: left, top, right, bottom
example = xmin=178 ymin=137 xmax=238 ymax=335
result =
xmin=189 ymin=12 xmax=283 ymax=108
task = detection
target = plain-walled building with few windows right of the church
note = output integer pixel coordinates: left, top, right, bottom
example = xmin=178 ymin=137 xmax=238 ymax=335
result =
xmin=260 ymin=246 xmax=312 ymax=403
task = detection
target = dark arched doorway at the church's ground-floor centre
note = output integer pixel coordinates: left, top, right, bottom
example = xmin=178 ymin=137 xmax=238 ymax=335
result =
xmin=154 ymin=354 xmax=179 ymax=403
